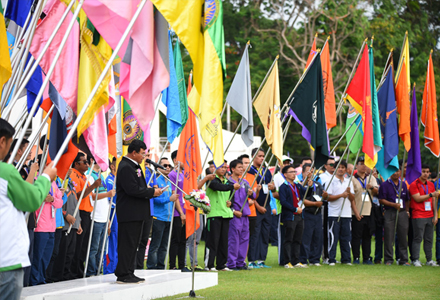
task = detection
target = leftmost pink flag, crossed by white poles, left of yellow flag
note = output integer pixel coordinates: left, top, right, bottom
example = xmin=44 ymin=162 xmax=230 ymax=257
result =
xmin=30 ymin=0 xmax=79 ymax=112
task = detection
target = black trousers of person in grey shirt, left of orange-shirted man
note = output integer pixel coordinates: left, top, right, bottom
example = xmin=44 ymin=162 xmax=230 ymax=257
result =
xmin=51 ymin=229 xmax=80 ymax=282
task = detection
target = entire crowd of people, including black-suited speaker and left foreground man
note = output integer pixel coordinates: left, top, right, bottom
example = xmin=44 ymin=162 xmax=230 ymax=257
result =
xmin=0 ymin=115 xmax=440 ymax=299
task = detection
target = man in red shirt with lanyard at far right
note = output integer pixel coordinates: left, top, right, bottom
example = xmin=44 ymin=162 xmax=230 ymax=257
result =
xmin=409 ymin=165 xmax=439 ymax=267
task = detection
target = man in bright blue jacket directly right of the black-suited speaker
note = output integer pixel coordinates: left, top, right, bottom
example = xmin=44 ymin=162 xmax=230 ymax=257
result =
xmin=147 ymin=157 xmax=179 ymax=270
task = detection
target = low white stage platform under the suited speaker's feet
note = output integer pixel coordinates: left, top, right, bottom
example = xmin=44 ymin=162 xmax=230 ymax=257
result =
xmin=21 ymin=270 xmax=218 ymax=300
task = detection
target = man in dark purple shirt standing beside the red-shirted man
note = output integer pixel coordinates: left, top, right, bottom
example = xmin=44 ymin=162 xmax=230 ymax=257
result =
xmin=378 ymin=170 xmax=410 ymax=266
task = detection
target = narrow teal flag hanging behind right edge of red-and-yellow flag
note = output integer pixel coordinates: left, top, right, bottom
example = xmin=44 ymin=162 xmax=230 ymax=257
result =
xmin=365 ymin=46 xmax=382 ymax=166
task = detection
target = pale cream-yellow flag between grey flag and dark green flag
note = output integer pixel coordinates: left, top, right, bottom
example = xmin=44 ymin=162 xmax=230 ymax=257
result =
xmin=254 ymin=60 xmax=284 ymax=162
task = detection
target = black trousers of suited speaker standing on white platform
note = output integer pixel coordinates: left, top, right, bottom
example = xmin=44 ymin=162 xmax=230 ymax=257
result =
xmin=115 ymin=221 xmax=144 ymax=279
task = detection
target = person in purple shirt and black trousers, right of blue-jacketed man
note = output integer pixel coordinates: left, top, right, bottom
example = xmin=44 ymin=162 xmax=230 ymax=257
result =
xmin=168 ymin=150 xmax=187 ymax=272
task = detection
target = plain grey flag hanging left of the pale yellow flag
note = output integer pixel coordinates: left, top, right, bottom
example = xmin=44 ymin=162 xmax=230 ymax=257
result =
xmin=226 ymin=46 xmax=254 ymax=147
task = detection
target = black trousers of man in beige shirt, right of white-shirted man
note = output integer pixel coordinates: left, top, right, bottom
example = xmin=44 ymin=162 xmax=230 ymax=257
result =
xmin=351 ymin=216 xmax=371 ymax=261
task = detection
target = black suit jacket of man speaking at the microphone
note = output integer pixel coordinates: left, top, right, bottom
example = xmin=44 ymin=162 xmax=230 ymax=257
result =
xmin=116 ymin=157 xmax=154 ymax=222
